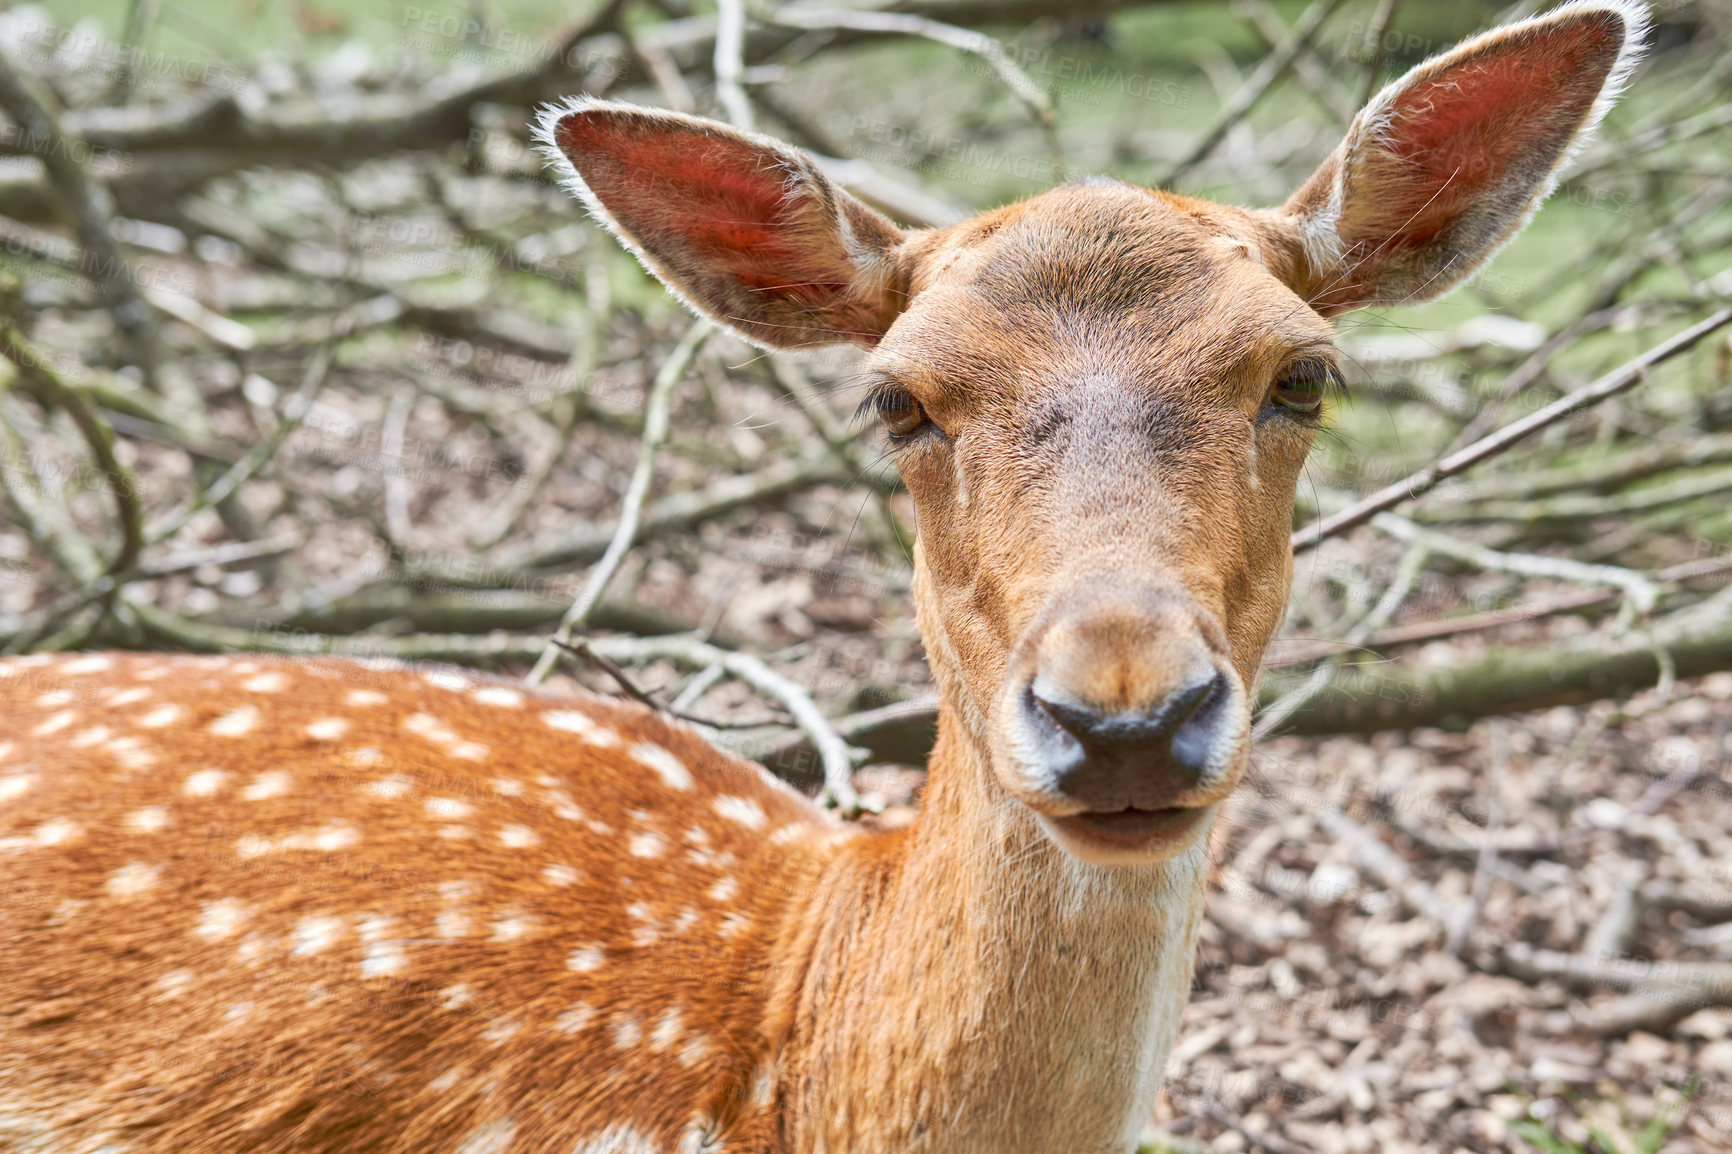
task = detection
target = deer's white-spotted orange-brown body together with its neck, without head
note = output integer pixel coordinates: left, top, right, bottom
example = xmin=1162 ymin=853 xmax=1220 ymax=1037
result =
xmin=0 ymin=655 xmax=1202 ymax=1154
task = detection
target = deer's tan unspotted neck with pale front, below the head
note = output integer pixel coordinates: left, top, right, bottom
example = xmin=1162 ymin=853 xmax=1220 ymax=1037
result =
xmin=788 ymin=706 xmax=1205 ymax=1154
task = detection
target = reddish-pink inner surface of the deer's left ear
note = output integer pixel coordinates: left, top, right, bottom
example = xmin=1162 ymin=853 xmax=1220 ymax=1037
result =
xmin=554 ymin=113 xmax=842 ymax=303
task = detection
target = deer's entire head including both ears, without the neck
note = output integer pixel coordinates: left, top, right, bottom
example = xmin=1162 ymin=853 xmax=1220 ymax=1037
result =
xmin=540 ymin=0 xmax=1644 ymax=865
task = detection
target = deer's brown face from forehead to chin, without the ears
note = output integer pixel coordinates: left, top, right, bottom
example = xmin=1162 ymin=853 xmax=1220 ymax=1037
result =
xmin=869 ymin=180 xmax=1337 ymax=856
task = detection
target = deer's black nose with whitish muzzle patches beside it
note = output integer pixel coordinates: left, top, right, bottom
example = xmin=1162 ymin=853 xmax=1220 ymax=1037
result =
xmin=1024 ymin=669 xmax=1233 ymax=809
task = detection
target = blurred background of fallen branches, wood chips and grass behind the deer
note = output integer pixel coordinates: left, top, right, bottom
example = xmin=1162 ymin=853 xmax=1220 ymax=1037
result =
xmin=0 ymin=0 xmax=1732 ymax=1154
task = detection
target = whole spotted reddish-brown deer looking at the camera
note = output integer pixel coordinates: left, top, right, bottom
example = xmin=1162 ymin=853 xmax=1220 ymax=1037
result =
xmin=0 ymin=0 xmax=1645 ymax=1154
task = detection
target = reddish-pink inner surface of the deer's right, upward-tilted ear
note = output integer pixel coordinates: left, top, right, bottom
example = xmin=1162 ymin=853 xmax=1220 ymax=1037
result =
xmin=1380 ymin=17 xmax=1623 ymax=248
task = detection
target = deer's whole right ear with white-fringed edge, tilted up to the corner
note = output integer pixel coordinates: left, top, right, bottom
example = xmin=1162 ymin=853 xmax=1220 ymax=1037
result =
xmin=1273 ymin=0 xmax=1647 ymax=315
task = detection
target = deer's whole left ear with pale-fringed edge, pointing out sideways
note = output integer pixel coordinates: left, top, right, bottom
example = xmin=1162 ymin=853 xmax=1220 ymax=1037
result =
xmin=535 ymin=99 xmax=908 ymax=348
